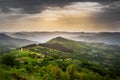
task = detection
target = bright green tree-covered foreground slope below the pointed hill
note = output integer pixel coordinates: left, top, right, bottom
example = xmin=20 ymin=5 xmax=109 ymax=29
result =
xmin=0 ymin=49 xmax=120 ymax=80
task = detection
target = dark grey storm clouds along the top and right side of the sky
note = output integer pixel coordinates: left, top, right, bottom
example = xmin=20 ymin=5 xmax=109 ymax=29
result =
xmin=0 ymin=0 xmax=120 ymax=30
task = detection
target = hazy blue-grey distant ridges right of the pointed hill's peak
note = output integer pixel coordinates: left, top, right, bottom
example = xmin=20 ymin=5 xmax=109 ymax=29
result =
xmin=73 ymin=33 xmax=120 ymax=45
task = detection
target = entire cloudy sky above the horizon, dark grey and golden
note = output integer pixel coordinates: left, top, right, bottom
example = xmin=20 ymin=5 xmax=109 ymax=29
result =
xmin=0 ymin=0 xmax=120 ymax=32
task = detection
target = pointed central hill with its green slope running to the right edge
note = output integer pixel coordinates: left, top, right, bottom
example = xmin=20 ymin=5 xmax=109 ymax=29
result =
xmin=40 ymin=37 xmax=120 ymax=66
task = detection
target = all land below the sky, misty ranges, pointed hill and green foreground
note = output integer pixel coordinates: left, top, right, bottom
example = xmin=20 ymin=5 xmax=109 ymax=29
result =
xmin=0 ymin=32 xmax=120 ymax=80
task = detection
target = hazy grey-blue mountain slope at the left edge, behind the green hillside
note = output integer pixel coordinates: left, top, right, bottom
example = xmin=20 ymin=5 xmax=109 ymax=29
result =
xmin=0 ymin=33 xmax=35 ymax=52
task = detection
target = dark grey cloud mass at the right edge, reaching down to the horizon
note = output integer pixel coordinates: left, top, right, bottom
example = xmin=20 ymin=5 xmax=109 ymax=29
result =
xmin=91 ymin=1 xmax=120 ymax=31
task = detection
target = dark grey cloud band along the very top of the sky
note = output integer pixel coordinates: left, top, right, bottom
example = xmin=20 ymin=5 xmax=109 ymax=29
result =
xmin=0 ymin=0 xmax=119 ymax=13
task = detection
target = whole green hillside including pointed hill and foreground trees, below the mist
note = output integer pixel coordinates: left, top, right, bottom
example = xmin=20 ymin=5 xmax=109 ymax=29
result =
xmin=0 ymin=37 xmax=120 ymax=80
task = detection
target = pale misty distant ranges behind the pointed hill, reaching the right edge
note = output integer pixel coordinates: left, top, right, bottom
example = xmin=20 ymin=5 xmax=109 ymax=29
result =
xmin=7 ymin=32 xmax=120 ymax=45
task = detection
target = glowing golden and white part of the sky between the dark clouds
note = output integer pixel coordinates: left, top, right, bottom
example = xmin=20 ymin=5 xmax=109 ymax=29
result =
xmin=0 ymin=2 xmax=114 ymax=32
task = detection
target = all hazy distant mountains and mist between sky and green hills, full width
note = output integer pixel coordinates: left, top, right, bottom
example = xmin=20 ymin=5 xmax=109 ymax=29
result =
xmin=0 ymin=32 xmax=120 ymax=52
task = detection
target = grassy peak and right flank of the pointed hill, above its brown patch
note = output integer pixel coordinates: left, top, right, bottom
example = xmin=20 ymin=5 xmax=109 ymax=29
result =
xmin=46 ymin=37 xmax=89 ymax=54
